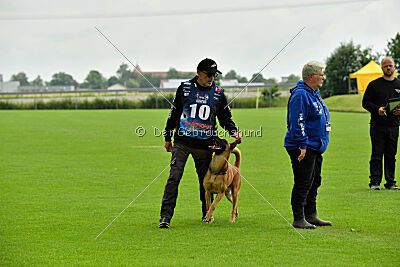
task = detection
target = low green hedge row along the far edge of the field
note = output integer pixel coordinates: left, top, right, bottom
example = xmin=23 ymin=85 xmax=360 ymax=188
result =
xmin=0 ymin=94 xmax=287 ymax=109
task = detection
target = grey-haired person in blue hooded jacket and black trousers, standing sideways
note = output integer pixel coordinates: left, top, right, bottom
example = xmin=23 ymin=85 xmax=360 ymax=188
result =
xmin=284 ymin=61 xmax=332 ymax=229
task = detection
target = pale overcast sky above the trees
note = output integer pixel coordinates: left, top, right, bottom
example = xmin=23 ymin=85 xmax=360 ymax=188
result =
xmin=0 ymin=0 xmax=400 ymax=82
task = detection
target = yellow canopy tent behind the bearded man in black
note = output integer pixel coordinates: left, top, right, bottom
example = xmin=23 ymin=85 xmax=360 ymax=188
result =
xmin=349 ymin=60 xmax=397 ymax=94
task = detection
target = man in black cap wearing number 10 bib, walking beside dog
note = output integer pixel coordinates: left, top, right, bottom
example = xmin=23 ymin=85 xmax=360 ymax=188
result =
xmin=158 ymin=58 xmax=242 ymax=228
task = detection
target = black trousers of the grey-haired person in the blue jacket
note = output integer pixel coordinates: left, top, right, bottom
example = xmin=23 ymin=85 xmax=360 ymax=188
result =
xmin=288 ymin=149 xmax=322 ymax=214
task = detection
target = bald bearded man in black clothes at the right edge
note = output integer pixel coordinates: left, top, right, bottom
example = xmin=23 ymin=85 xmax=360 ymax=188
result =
xmin=362 ymin=57 xmax=400 ymax=190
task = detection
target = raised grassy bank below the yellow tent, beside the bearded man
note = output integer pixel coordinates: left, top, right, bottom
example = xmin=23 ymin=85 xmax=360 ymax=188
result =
xmin=324 ymin=95 xmax=367 ymax=113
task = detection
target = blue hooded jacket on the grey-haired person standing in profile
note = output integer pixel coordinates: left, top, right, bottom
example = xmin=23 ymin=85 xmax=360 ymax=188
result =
xmin=284 ymin=80 xmax=330 ymax=153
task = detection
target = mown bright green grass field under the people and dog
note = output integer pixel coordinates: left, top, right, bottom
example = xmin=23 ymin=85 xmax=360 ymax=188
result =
xmin=0 ymin=108 xmax=400 ymax=266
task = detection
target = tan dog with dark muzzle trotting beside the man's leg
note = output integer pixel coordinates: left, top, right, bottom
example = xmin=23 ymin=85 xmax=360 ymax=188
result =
xmin=203 ymin=138 xmax=242 ymax=223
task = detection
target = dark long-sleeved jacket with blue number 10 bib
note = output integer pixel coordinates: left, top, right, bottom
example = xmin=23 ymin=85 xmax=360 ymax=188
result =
xmin=164 ymin=76 xmax=237 ymax=149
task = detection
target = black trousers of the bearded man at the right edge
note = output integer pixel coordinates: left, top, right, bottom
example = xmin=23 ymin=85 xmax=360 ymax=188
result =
xmin=369 ymin=124 xmax=399 ymax=187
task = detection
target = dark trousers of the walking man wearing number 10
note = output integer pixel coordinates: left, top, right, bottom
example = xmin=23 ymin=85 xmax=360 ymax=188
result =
xmin=160 ymin=144 xmax=212 ymax=221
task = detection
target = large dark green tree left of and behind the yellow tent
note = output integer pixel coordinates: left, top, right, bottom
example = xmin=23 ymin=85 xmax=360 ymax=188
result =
xmin=321 ymin=41 xmax=379 ymax=97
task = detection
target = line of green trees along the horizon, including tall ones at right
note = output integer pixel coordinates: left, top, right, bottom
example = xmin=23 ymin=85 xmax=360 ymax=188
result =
xmin=7 ymin=33 xmax=400 ymax=97
